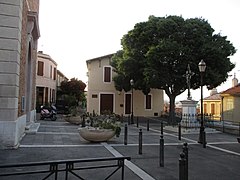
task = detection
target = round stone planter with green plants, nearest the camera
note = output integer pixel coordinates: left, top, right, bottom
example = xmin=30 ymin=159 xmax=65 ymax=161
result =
xmin=78 ymin=112 xmax=121 ymax=142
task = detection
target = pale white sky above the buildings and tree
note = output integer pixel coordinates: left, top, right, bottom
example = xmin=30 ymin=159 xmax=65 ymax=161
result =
xmin=38 ymin=0 xmax=240 ymax=101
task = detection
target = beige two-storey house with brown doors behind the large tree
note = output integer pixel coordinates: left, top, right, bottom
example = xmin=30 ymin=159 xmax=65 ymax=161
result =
xmin=86 ymin=54 xmax=164 ymax=116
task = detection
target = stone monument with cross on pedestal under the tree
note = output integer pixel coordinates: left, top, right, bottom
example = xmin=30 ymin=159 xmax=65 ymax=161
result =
xmin=180 ymin=64 xmax=199 ymax=128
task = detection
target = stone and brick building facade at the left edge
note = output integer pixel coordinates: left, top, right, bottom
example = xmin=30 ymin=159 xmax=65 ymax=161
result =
xmin=0 ymin=0 xmax=40 ymax=148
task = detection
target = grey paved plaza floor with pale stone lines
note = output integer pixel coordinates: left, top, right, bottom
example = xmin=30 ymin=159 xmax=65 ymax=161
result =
xmin=0 ymin=117 xmax=240 ymax=180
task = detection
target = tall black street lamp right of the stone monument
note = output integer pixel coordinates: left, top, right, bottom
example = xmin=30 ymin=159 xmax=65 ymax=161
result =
xmin=198 ymin=60 xmax=206 ymax=147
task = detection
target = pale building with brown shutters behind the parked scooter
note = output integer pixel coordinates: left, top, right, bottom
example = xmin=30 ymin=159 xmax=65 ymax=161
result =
xmin=36 ymin=51 xmax=57 ymax=106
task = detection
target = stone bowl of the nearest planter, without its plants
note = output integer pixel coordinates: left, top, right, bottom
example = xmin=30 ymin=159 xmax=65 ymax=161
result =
xmin=78 ymin=127 xmax=115 ymax=142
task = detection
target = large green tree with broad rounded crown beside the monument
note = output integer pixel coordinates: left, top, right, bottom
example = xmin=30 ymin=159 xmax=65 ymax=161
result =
xmin=112 ymin=16 xmax=236 ymax=121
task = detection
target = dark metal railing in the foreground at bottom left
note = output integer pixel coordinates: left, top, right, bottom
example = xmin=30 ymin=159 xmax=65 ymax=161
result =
xmin=0 ymin=157 xmax=131 ymax=180
